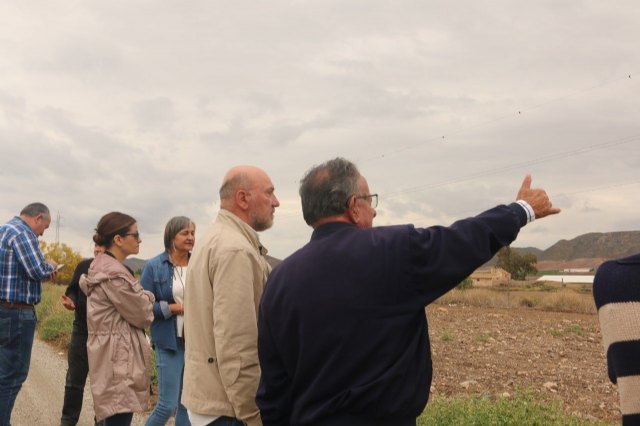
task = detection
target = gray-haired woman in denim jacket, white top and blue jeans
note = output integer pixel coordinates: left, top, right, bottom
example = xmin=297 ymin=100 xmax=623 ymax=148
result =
xmin=140 ymin=216 xmax=196 ymax=426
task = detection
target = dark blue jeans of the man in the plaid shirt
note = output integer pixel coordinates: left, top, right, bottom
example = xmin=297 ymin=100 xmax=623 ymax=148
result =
xmin=0 ymin=306 xmax=36 ymax=426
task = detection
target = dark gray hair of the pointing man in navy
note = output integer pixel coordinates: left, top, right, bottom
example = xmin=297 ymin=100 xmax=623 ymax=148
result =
xmin=299 ymin=157 xmax=360 ymax=225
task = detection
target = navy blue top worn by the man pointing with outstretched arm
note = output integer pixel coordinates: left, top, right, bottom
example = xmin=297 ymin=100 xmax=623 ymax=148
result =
xmin=256 ymin=204 xmax=526 ymax=426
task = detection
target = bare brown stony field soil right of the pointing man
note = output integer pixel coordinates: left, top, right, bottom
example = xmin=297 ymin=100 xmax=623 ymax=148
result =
xmin=427 ymin=304 xmax=620 ymax=424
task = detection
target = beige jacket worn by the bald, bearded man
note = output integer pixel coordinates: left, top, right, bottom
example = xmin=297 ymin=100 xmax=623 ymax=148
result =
xmin=182 ymin=210 xmax=271 ymax=426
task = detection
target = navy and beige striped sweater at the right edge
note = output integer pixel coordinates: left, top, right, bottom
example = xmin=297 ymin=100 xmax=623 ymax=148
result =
xmin=593 ymin=254 xmax=640 ymax=425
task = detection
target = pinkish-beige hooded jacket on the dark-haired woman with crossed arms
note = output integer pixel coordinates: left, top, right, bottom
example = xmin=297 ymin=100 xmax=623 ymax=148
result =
xmin=80 ymin=254 xmax=155 ymax=421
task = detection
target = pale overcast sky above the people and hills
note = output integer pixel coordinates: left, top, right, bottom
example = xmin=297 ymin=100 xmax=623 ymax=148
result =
xmin=0 ymin=0 xmax=640 ymax=259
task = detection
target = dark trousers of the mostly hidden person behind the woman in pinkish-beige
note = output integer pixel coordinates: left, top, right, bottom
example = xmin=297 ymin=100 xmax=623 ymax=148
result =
xmin=60 ymin=325 xmax=89 ymax=426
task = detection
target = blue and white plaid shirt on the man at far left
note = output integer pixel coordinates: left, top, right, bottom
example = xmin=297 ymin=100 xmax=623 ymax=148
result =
xmin=0 ymin=216 xmax=53 ymax=305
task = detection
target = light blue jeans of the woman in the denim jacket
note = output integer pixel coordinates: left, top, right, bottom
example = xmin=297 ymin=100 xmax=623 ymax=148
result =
xmin=145 ymin=341 xmax=191 ymax=426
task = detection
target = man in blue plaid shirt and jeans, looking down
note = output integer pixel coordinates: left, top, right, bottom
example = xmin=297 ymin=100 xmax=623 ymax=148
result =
xmin=0 ymin=203 xmax=58 ymax=426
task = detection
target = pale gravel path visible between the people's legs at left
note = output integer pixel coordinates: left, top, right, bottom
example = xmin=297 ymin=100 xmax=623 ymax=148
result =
xmin=11 ymin=339 xmax=155 ymax=426
